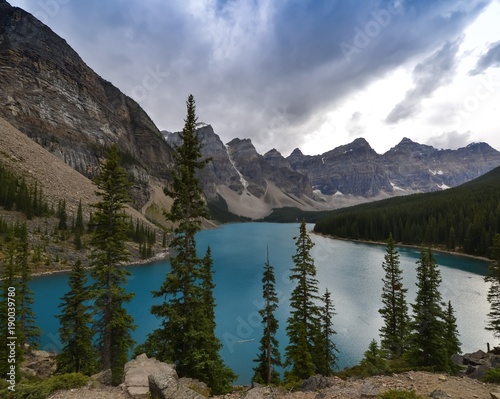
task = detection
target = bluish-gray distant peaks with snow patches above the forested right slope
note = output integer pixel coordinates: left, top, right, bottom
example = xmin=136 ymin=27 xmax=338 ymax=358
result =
xmin=287 ymin=138 xmax=500 ymax=197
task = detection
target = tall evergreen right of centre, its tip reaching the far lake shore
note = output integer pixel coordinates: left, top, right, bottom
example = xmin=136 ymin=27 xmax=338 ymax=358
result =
xmin=285 ymin=221 xmax=321 ymax=382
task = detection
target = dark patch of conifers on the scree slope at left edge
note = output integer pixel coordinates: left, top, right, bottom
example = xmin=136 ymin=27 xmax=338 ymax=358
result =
xmin=0 ymin=165 xmax=50 ymax=219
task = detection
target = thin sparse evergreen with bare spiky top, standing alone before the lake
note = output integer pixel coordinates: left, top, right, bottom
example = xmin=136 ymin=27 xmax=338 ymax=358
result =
xmin=253 ymin=250 xmax=281 ymax=385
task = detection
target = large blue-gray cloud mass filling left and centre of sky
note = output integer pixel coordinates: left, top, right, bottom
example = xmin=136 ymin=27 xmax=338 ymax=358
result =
xmin=8 ymin=0 xmax=489 ymax=154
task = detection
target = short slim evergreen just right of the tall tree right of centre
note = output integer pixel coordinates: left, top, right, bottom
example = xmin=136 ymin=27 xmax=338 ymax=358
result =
xmin=315 ymin=288 xmax=338 ymax=376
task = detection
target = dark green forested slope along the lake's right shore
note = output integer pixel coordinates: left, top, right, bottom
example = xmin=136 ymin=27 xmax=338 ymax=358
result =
xmin=314 ymin=168 xmax=500 ymax=256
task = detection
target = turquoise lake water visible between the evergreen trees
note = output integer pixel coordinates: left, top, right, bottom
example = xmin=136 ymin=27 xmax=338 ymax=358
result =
xmin=31 ymin=223 xmax=495 ymax=384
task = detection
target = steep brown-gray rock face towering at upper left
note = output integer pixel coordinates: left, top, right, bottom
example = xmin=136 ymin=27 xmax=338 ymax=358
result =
xmin=0 ymin=2 xmax=172 ymax=208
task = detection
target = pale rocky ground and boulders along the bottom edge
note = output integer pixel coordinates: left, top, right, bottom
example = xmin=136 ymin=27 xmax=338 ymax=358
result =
xmin=42 ymin=355 xmax=500 ymax=399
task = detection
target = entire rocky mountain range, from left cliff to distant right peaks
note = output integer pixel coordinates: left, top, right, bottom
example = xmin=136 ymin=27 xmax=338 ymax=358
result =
xmin=0 ymin=0 xmax=500 ymax=223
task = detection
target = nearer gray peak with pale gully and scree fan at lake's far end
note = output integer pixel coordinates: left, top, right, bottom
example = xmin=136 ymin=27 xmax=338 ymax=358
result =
xmin=163 ymin=125 xmax=320 ymax=219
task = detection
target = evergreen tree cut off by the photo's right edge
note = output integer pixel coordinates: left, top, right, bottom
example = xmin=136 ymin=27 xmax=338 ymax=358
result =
xmin=485 ymin=234 xmax=500 ymax=338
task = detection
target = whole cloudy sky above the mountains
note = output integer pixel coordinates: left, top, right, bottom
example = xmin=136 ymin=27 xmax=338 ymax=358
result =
xmin=9 ymin=0 xmax=500 ymax=156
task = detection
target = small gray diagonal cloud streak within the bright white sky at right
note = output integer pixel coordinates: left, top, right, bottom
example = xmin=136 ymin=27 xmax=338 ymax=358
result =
xmin=385 ymin=40 xmax=460 ymax=124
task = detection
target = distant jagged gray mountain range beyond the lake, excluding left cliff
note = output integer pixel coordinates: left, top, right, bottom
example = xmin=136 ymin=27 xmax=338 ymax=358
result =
xmin=166 ymin=125 xmax=500 ymax=218
